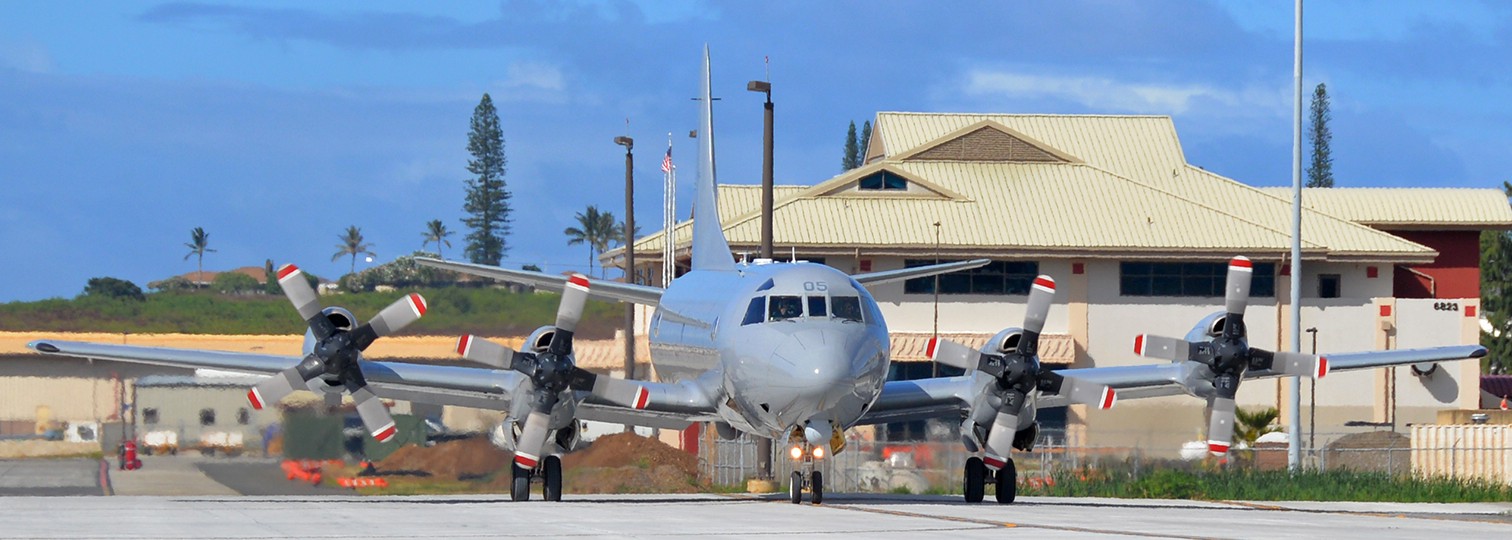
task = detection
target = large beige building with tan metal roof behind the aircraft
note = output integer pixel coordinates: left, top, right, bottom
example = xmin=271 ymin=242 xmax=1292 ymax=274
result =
xmin=603 ymin=112 xmax=1512 ymax=449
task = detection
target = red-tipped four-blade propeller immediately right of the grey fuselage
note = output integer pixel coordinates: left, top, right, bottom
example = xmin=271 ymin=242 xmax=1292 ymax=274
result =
xmin=927 ymin=275 xmax=1117 ymax=470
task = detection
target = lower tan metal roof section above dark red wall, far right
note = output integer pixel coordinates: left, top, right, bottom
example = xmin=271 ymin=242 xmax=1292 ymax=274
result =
xmin=1261 ymin=188 xmax=1512 ymax=230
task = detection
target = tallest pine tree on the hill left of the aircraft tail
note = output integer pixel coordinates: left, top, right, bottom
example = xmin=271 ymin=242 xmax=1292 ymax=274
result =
xmin=463 ymin=94 xmax=511 ymax=266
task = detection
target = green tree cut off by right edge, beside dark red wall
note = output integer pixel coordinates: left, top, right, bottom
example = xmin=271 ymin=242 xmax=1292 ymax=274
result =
xmin=1480 ymin=182 xmax=1512 ymax=375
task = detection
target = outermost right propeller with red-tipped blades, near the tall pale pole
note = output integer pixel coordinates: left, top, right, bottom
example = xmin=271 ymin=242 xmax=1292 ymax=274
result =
xmin=1134 ymin=256 xmax=1328 ymax=455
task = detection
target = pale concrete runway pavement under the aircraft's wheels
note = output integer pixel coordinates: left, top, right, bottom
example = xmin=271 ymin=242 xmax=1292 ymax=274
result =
xmin=0 ymin=493 xmax=1512 ymax=540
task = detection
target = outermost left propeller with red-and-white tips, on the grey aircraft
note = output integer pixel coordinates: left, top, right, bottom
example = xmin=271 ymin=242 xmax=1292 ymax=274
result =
xmin=246 ymin=265 xmax=426 ymax=442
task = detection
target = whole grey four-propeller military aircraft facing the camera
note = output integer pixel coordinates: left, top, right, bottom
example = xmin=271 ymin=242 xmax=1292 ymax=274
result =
xmin=30 ymin=48 xmax=1485 ymax=504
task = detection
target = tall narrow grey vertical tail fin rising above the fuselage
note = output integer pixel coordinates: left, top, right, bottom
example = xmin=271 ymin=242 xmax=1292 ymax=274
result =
xmin=692 ymin=44 xmax=735 ymax=271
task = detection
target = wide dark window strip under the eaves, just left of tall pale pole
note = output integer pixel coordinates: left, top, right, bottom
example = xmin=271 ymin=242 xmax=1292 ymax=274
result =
xmin=1119 ymin=262 xmax=1276 ymax=298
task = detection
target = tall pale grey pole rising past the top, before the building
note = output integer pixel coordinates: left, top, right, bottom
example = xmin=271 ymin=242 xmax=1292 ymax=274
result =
xmin=1287 ymin=0 xmax=1302 ymax=472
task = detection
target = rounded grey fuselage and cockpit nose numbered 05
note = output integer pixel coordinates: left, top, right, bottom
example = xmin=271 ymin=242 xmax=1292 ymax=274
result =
xmin=650 ymin=262 xmax=889 ymax=440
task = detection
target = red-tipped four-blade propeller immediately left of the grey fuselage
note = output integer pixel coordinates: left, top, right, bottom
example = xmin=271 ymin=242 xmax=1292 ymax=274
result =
xmin=457 ymin=274 xmax=650 ymax=469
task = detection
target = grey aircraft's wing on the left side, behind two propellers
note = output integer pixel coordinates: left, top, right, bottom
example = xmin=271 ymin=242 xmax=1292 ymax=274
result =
xmin=27 ymin=340 xmax=714 ymax=430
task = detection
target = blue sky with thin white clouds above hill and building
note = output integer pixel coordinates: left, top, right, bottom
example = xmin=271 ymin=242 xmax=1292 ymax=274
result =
xmin=0 ymin=0 xmax=1512 ymax=301
